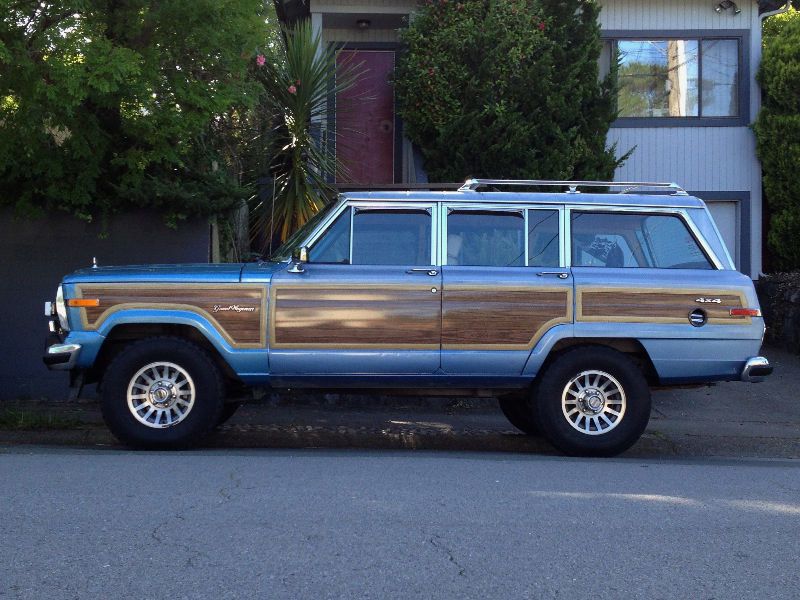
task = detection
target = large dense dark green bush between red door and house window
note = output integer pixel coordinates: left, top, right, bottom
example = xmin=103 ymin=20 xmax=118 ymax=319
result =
xmin=395 ymin=0 xmax=625 ymax=181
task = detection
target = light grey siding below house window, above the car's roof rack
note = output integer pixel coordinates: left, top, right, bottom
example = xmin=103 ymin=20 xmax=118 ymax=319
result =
xmin=608 ymin=127 xmax=760 ymax=190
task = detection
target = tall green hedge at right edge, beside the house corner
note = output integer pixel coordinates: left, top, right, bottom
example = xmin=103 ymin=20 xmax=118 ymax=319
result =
xmin=754 ymin=18 xmax=800 ymax=269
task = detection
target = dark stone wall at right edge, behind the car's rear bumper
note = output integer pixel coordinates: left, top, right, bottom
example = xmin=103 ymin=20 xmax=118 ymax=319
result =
xmin=756 ymin=271 xmax=800 ymax=354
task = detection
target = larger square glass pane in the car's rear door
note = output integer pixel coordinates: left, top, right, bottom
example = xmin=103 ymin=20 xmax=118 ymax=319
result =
xmin=447 ymin=210 xmax=525 ymax=267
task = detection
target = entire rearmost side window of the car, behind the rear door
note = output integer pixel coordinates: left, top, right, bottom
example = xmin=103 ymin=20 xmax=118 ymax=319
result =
xmin=571 ymin=211 xmax=713 ymax=269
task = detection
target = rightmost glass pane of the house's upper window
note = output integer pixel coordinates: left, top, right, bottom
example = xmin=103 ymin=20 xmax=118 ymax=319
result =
xmin=702 ymin=40 xmax=739 ymax=117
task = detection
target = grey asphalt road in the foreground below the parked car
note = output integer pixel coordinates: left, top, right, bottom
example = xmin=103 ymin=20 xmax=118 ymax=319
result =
xmin=0 ymin=447 xmax=800 ymax=600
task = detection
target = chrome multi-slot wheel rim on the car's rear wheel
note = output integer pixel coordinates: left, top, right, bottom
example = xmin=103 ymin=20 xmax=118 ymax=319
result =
xmin=561 ymin=371 xmax=627 ymax=435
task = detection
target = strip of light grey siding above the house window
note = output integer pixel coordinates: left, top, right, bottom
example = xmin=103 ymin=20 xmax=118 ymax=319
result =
xmin=600 ymin=0 xmax=758 ymax=30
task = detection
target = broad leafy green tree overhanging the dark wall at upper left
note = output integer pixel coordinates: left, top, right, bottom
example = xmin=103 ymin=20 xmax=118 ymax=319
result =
xmin=0 ymin=0 xmax=268 ymax=220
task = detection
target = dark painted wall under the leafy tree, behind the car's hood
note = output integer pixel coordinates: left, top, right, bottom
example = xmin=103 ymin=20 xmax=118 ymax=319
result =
xmin=0 ymin=209 xmax=210 ymax=400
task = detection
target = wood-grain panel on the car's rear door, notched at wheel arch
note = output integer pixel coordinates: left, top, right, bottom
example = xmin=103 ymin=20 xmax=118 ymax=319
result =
xmin=442 ymin=287 xmax=572 ymax=349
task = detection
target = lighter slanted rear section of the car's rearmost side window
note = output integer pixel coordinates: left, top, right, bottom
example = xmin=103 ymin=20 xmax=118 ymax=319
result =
xmin=643 ymin=215 xmax=711 ymax=269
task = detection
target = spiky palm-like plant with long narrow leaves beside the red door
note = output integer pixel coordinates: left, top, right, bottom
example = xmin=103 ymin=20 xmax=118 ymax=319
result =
xmin=253 ymin=21 xmax=361 ymax=242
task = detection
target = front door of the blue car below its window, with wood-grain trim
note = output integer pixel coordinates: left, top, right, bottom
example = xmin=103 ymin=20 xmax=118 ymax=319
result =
xmin=269 ymin=263 xmax=442 ymax=374
